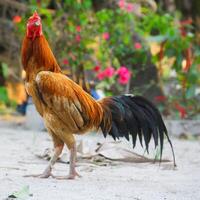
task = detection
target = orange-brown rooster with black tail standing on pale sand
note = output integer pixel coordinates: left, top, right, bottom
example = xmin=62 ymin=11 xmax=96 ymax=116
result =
xmin=21 ymin=12 xmax=175 ymax=179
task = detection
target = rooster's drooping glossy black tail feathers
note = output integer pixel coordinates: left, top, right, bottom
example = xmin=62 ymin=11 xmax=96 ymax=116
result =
xmin=100 ymin=95 xmax=176 ymax=166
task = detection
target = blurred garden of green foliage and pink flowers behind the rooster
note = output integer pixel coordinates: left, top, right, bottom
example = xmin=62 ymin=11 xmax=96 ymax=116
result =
xmin=0 ymin=0 xmax=200 ymax=132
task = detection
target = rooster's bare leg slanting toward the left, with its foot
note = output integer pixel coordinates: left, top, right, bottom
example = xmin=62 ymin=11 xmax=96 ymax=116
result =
xmin=25 ymin=145 xmax=64 ymax=178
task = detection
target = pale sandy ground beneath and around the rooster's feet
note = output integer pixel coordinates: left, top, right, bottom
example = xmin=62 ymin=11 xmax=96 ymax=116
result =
xmin=0 ymin=120 xmax=200 ymax=200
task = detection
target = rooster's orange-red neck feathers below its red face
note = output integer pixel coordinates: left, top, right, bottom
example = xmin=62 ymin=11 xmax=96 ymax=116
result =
xmin=21 ymin=35 xmax=61 ymax=80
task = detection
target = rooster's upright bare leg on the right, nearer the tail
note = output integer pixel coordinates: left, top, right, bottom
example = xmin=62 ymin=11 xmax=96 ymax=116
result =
xmin=55 ymin=143 xmax=81 ymax=180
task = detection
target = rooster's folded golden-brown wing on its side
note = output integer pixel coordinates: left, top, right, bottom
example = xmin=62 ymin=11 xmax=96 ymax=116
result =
xmin=36 ymin=71 xmax=102 ymax=132
